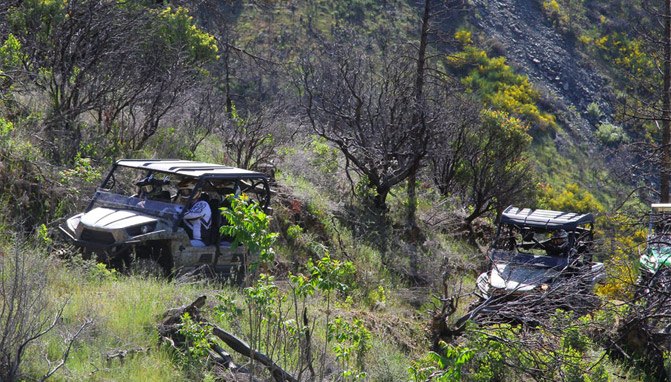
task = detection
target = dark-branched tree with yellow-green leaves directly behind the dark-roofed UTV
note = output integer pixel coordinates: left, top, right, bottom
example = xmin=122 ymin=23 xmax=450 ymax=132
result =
xmin=430 ymin=107 xmax=533 ymax=239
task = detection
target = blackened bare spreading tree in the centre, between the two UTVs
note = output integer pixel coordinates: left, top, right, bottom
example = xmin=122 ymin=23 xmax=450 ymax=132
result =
xmin=302 ymin=43 xmax=439 ymax=211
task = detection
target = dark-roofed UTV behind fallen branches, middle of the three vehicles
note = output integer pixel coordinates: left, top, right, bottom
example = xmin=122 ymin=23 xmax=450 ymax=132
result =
xmin=476 ymin=206 xmax=605 ymax=300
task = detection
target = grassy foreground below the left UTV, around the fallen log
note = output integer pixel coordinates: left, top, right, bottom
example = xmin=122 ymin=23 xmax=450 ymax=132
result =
xmin=6 ymin=239 xmax=423 ymax=381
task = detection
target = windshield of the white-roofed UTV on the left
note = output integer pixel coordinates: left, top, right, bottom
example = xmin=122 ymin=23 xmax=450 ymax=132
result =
xmin=91 ymin=190 xmax=184 ymax=221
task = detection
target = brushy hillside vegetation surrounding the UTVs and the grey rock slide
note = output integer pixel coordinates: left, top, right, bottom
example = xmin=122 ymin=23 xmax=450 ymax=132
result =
xmin=0 ymin=0 xmax=669 ymax=381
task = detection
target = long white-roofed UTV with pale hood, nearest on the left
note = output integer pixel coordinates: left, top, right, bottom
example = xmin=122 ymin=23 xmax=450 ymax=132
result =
xmin=60 ymin=159 xmax=271 ymax=276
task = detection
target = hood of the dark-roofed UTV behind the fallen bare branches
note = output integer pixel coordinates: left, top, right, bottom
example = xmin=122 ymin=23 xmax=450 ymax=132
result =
xmin=489 ymin=263 xmax=560 ymax=292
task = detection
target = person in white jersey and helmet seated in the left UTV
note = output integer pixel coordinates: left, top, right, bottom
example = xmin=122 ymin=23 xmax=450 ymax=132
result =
xmin=177 ymin=179 xmax=212 ymax=247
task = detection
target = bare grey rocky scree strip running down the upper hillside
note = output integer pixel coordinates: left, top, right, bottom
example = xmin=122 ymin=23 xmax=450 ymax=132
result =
xmin=473 ymin=0 xmax=611 ymax=141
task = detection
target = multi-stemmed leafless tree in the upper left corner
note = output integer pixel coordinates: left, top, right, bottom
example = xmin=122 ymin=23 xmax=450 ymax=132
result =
xmin=6 ymin=1 xmax=147 ymax=161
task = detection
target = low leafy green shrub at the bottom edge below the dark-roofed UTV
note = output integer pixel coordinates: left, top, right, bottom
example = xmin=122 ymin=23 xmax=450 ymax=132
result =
xmin=410 ymin=320 xmax=608 ymax=382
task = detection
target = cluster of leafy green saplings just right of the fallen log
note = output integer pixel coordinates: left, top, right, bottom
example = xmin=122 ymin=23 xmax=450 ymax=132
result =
xmin=214 ymin=253 xmax=362 ymax=380
